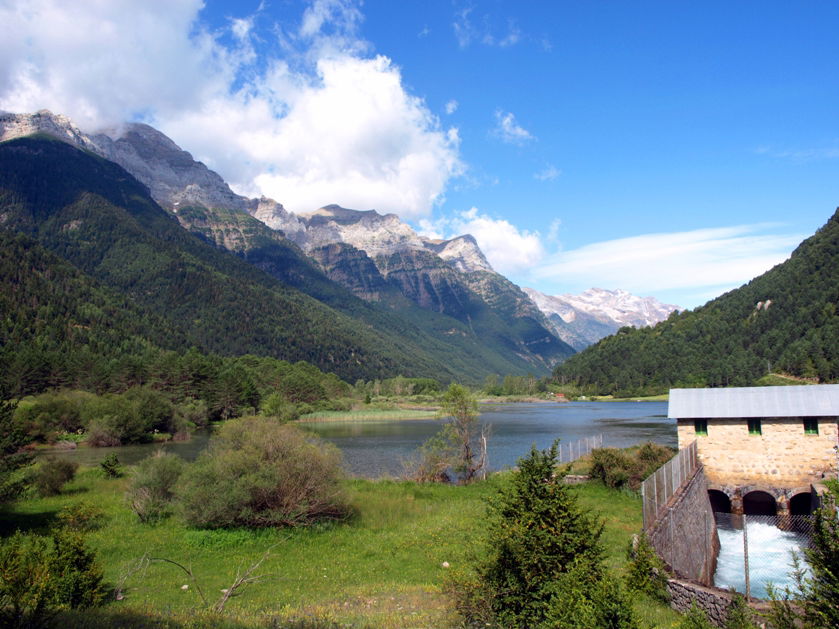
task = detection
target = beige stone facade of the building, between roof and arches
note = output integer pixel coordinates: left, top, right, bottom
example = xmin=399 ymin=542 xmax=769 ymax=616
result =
xmin=678 ymin=417 xmax=837 ymax=491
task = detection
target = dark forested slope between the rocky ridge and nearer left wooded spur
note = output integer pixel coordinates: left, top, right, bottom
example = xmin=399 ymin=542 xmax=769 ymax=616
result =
xmin=0 ymin=137 xmax=455 ymax=381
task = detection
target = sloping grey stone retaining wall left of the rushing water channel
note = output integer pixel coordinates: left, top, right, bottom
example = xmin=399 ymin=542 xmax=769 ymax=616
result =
xmin=647 ymin=465 xmax=720 ymax=585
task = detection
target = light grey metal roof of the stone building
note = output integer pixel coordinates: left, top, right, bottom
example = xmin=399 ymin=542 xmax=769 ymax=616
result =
xmin=667 ymin=384 xmax=839 ymax=419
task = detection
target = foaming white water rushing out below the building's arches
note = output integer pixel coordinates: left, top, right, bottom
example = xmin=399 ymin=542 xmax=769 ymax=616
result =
xmin=714 ymin=516 xmax=806 ymax=598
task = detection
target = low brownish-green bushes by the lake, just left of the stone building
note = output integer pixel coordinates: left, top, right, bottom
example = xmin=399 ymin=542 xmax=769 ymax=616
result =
xmin=589 ymin=442 xmax=675 ymax=490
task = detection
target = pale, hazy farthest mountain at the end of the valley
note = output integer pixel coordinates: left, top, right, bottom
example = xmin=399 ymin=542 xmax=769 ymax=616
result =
xmin=523 ymin=288 xmax=682 ymax=351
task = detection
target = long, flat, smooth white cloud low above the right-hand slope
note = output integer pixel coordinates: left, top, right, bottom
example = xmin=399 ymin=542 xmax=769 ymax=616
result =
xmin=531 ymin=225 xmax=802 ymax=306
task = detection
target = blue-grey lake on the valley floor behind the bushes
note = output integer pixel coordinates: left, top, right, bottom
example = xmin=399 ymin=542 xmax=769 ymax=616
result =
xmin=44 ymin=402 xmax=676 ymax=478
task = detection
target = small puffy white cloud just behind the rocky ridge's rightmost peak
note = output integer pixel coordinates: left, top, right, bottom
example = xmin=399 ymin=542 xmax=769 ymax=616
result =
xmin=418 ymin=207 xmax=545 ymax=275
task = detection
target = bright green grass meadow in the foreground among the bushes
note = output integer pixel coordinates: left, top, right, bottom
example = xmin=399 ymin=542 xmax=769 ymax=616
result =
xmin=0 ymin=468 xmax=677 ymax=628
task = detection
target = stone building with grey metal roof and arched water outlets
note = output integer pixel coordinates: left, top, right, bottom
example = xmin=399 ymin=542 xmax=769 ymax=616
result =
xmin=668 ymin=384 xmax=839 ymax=514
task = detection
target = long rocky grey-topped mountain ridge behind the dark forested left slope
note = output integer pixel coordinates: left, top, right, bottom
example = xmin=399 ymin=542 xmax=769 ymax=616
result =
xmin=0 ymin=111 xmax=573 ymax=373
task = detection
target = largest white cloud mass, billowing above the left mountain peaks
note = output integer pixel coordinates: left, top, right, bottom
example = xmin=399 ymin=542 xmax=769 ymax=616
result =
xmin=0 ymin=0 xmax=462 ymax=219
